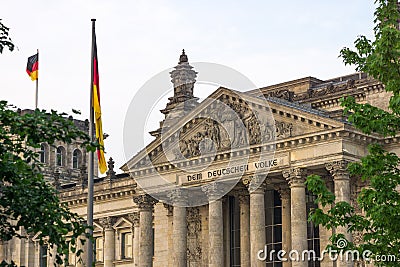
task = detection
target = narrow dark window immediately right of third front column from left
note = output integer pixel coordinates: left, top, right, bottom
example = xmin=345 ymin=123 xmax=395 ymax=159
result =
xmin=229 ymin=196 xmax=240 ymax=267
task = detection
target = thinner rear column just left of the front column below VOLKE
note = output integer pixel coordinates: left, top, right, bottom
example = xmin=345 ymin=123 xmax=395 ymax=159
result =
xmin=238 ymin=190 xmax=250 ymax=267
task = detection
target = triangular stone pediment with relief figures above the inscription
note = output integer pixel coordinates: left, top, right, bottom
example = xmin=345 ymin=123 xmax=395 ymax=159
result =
xmin=122 ymin=87 xmax=344 ymax=171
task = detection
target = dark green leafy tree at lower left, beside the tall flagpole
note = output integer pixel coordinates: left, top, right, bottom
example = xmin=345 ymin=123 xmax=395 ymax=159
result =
xmin=0 ymin=101 xmax=95 ymax=266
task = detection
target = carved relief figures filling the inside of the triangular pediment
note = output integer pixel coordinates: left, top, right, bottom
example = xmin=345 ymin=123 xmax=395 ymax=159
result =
xmin=174 ymin=97 xmax=293 ymax=160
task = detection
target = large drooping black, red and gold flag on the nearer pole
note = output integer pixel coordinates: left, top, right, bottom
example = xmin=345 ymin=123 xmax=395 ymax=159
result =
xmin=92 ymin=35 xmax=107 ymax=173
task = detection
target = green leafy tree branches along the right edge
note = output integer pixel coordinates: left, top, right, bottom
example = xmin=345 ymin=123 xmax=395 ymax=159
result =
xmin=306 ymin=0 xmax=400 ymax=266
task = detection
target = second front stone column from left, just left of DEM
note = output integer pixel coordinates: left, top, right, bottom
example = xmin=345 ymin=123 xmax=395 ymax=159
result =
xmin=168 ymin=189 xmax=187 ymax=267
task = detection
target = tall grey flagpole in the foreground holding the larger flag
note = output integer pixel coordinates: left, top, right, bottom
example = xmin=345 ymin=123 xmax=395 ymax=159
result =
xmin=87 ymin=19 xmax=96 ymax=267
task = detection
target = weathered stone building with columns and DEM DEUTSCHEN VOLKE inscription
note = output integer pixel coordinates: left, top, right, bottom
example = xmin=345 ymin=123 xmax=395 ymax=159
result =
xmin=0 ymin=54 xmax=399 ymax=267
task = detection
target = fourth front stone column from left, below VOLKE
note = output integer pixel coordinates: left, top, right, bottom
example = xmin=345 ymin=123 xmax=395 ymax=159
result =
xmin=243 ymin=176 xmax=266 ymax=267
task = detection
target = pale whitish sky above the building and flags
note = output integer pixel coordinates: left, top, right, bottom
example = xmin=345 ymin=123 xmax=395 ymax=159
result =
xmin=0 ymin=0 xmax=374 ymax=175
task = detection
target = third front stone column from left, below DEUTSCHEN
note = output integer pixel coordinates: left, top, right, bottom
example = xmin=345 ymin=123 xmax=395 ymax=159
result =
xmin=203 ymin=182 xmax=224 ymax=267
